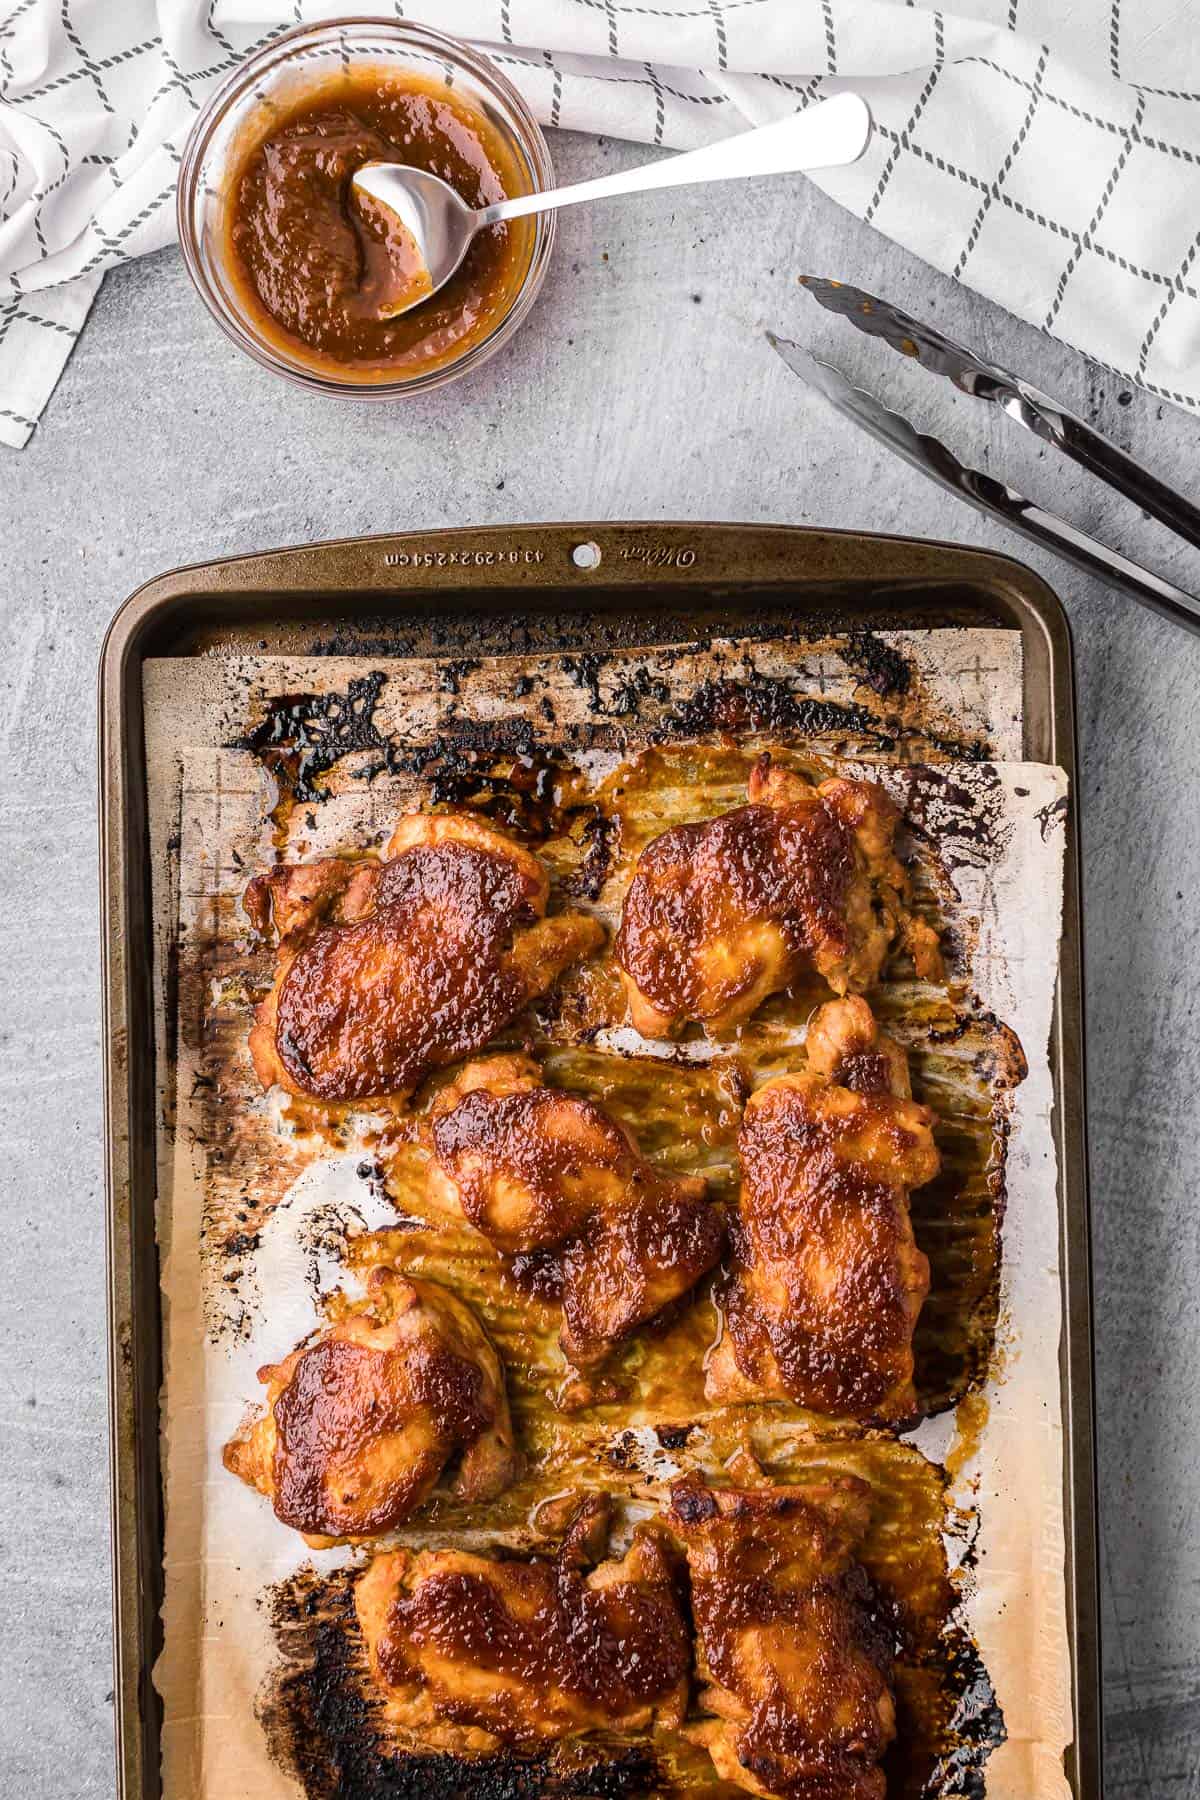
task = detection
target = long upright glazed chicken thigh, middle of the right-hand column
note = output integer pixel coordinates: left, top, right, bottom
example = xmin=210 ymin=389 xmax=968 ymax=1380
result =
xmin=705 ymin=997 xmax=939 ymax=1420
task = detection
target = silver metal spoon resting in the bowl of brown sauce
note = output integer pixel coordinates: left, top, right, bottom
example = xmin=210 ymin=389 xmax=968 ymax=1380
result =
xmin=351 ymin=94 xmax=873 ymax=317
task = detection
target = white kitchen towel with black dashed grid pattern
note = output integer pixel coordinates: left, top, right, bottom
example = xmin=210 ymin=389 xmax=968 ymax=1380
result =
xmin=0 ymin=0 xmax=1200 ymax=445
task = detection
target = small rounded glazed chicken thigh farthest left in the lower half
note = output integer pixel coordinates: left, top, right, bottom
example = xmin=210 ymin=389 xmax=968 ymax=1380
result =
xmin=225 ymin=1267 xmax=520 ymax=1548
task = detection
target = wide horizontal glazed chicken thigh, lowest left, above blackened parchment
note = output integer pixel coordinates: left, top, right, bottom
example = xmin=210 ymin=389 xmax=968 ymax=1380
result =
xmin=356 ymin=1498 xmax=691 ymax=1748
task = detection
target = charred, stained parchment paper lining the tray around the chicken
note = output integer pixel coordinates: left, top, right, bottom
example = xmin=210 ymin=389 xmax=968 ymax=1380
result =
xmin=146 ymin=632 xmax=1072 ymax=1800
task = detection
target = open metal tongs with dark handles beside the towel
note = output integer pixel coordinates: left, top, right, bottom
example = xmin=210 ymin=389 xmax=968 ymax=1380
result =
xmin=766 ymin=275 xmax=1200 ymax=634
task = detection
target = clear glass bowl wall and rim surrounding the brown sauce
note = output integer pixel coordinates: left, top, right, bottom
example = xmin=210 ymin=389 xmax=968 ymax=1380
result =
xmin=178 ymin=18 xmax=554 ymax=400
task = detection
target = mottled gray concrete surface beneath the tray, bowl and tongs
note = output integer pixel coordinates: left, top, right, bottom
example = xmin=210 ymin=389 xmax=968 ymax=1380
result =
xmin=0 ymin=137 xmax=1200 ymax=1800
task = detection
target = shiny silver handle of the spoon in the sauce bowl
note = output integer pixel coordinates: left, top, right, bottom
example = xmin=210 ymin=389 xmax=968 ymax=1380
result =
xmin=477 ymin=94 xmax=871 ymax=225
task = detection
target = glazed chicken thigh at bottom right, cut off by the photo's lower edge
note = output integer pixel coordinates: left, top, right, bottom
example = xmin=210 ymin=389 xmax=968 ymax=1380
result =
xmin=666 ymin=1476 xmax=896 ymax=1800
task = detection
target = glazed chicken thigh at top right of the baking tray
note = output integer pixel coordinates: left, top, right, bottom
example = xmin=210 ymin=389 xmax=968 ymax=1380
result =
xmin=615 ymin=758 xmax=941 ymax=1037
